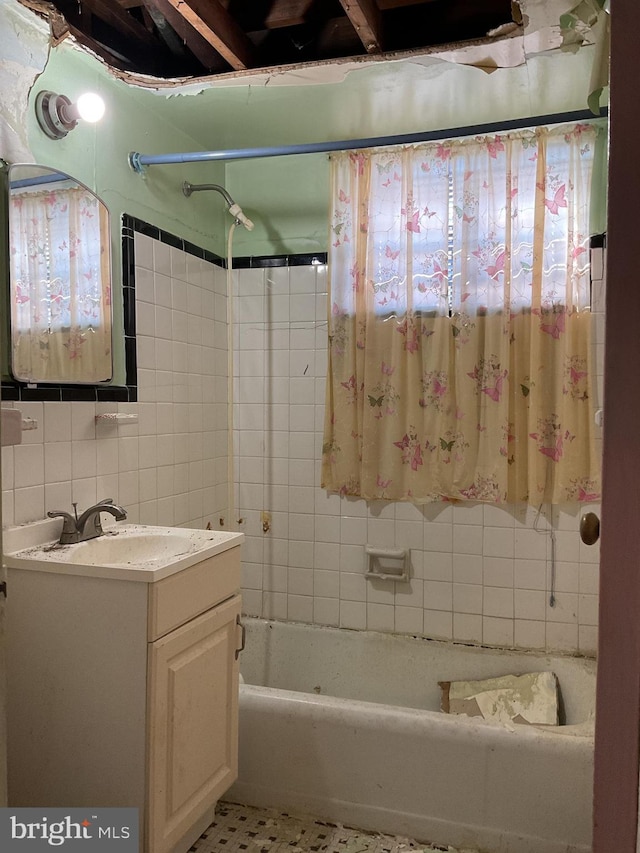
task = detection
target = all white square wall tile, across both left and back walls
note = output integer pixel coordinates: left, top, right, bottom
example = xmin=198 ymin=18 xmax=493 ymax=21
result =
xmin=2 ymin=240 xmax=604 ymax=654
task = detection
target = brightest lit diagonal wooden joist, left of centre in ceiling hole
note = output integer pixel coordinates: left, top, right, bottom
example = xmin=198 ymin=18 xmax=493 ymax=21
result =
xmin=159 ymin=0 xmax=255 ymax=71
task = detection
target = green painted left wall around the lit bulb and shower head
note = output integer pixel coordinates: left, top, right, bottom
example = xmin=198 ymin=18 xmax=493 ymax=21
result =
xmin=28 ymin=42 xmax=226 ymax=251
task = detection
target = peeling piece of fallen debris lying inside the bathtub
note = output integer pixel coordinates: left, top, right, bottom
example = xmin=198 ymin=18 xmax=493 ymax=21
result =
xmin=438 ymin=672 xmax=559 ymax=726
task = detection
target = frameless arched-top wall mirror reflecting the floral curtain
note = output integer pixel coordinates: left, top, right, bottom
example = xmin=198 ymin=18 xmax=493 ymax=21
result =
xmin=9 ymin=165 xmax=113 ymax=385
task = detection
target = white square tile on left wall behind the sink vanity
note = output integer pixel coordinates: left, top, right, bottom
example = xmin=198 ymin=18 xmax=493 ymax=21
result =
xmin=2 ymin=234 xmax=227 ymax=527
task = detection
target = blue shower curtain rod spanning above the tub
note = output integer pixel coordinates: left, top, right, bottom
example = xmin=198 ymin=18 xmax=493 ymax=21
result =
xmin=129 ymin=108 xmax=608 ymax=174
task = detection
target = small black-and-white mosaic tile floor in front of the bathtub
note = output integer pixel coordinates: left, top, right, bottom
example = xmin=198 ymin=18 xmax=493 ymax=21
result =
xmin=191 ymin=803 xmax=474 ymax=853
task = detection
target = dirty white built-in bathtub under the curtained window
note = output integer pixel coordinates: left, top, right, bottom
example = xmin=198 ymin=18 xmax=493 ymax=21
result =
xmin=225 ymin=619 xmax=595 ymax=853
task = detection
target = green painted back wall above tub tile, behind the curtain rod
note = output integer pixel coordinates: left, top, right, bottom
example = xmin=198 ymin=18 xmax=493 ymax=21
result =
xmin=221 ymin=50 xmax=591 ymax=255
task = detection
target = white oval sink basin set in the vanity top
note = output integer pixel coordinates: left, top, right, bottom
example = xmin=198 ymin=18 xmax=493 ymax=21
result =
xmin=66 ymin=532 xmax=198 ymax=566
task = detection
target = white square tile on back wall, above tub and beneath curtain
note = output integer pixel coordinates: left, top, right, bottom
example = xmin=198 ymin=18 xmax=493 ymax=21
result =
xmin=234 ymin=264 xmax=604 ymax=654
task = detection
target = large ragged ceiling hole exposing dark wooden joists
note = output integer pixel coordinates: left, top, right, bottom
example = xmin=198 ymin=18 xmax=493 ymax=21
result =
xmin=41 ymin=0 xmax=522 ymax=79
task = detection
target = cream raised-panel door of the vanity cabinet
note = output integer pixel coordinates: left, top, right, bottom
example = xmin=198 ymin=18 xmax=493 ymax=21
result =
xmin=147 ymin=595 xmax=240 ymax=853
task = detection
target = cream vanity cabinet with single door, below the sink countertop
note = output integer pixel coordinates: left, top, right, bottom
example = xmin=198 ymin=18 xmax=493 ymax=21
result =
xmin=6 ymin=536 xmax=242 ymax=853
